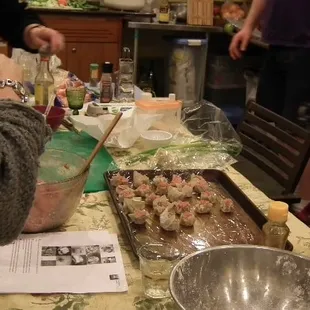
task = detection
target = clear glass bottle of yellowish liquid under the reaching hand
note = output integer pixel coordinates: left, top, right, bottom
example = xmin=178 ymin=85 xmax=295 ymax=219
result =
xmin=34 ymin=55 xmax=55 ymax=106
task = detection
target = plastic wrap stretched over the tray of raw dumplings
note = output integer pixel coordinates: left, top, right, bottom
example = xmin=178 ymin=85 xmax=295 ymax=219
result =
xmin=106 ymin=170 xmax=266 ymax=254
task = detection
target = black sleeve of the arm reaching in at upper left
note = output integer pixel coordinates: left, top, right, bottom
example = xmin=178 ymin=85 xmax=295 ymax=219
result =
xmin=0 ymin=0 xmax=42 ymax=52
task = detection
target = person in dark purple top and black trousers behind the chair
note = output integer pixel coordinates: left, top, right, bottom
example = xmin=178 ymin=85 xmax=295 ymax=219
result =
xmin=229 ymin=0 xmax=310 ymax=224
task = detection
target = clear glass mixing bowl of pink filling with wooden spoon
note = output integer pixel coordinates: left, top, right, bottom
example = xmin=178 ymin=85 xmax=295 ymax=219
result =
xmin=24 ymin=149 xmax=88 ymax=233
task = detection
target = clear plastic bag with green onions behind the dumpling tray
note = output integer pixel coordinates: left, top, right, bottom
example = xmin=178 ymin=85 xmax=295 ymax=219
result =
xmin=118 ymin=101 xmax=242 ymax=170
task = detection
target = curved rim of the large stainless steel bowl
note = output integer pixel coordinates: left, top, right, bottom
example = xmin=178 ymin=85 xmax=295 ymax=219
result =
xmin=169 ymin=245 xmax=310 ymax=310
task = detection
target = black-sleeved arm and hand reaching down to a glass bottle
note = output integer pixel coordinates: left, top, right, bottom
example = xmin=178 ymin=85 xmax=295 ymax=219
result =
xmin=0 ymin=0 xmax=65 ymax=54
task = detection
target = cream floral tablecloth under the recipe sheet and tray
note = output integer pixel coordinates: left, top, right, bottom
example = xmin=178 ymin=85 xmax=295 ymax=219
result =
xmin=0 ymin=167 xmax=310 ymax=310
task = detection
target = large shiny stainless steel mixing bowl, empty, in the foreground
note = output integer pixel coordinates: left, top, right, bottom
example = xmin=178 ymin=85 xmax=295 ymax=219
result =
xmin=170 ymin=245 xmax=310 ymax=310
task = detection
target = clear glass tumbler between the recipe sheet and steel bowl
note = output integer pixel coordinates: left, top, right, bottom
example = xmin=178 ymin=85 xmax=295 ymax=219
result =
xmin=138 ymin=244 xmax=181 ymax=299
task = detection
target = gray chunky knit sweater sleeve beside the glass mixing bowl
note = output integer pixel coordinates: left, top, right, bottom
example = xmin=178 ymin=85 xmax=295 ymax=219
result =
xmin=0 ymin=100 xmax=51 ymax=245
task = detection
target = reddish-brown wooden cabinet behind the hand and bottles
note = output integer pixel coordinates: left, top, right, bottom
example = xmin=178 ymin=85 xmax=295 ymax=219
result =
xmin=40 ymin=14 xmax=123 ymax=81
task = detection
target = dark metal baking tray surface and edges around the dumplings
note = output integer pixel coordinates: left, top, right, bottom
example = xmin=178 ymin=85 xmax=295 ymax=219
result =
xmin=104 ymin=169 xmax=293 ymax=255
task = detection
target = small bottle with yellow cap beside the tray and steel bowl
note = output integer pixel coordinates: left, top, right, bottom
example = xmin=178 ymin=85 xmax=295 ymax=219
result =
xmin=263 ymin=201 xmax=290 ymax=249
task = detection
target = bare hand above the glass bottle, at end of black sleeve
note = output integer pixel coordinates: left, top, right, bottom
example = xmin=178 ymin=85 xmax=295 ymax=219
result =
xmin=24 ymin=25 xmax=65 ymax=54
